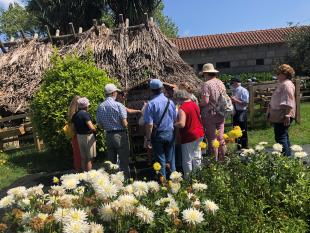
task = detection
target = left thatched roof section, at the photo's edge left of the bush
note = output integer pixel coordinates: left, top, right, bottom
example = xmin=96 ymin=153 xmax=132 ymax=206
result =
xmin=0 ymin=41 xmax=53 ymax=113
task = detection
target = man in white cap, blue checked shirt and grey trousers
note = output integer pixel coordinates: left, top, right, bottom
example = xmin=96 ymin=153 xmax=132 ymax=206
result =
xmin=96 ymin=84 xmax=130 ymax=178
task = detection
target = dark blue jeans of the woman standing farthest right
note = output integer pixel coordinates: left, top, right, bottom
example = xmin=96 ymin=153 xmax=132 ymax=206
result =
xmin=273 ymin=123 xmax=291 ymax=156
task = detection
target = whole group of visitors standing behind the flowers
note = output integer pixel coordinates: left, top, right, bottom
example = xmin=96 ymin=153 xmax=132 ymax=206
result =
xmin=68 ymin=63 xmax=295 ymax=178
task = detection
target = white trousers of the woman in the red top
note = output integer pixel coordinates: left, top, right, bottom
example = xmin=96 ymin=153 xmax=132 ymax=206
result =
xmin=181 ymin=138 xmax=202 ymax=178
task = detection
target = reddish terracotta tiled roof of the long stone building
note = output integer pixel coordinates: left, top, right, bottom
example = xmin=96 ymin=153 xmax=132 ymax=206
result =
xmin=172 ymin=27 xmax=300 ymax=52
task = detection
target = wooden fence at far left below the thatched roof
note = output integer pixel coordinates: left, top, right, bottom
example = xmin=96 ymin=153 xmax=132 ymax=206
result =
xmin=0 ymin=114 xmax=43 ymax=151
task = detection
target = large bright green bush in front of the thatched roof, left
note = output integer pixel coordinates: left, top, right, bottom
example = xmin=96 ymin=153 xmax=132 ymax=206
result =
xmin=31 ymin=53 xmax=117 ymax=150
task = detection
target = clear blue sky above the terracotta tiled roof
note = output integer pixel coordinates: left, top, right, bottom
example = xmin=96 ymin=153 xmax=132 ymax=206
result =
xmin=163 ymin=0 xmax=310 ymax=36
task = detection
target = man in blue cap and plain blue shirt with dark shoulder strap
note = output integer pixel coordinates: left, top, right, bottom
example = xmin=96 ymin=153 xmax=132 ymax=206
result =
xmin=144 ymin=79 xmax=177 ymax=178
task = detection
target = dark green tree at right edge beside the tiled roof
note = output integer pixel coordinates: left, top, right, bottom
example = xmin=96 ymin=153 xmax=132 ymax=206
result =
xmin=287 ymin=26 xmax=310 ymax=75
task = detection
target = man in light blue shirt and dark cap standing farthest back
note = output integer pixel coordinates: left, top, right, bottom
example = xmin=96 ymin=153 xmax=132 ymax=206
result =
xmin=231 ymin=78 xmax=249 ymax=149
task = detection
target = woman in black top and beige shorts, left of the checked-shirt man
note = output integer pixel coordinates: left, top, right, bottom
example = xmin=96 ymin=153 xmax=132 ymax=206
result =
xmin=72 ymin=97 xmax=96 ymax=171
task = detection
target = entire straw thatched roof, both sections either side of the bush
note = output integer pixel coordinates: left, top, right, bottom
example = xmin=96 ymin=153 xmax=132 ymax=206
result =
xmin=0 ymin=22 xmax=201 ymax=112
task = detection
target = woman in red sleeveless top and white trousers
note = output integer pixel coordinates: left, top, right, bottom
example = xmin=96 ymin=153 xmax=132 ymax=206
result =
xmin=174 ymin=90 xmax=204 ymax=177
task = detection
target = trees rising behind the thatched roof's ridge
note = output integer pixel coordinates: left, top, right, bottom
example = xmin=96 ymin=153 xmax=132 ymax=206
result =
xmin=0 ymin=0 xmax=178 ymax=38
